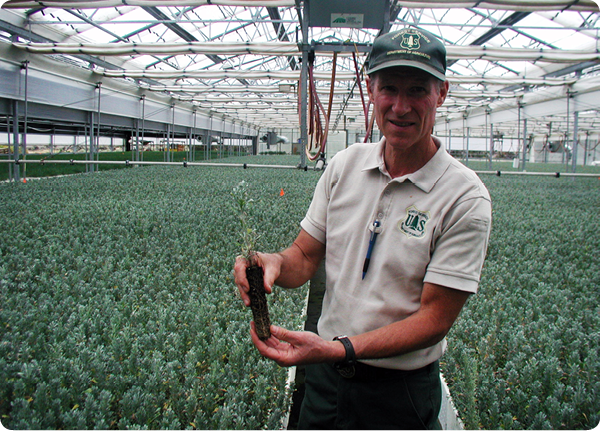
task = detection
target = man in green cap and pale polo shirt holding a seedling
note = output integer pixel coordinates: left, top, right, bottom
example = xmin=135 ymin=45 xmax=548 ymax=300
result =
xmin=234 ymin=29 xmax=491 ymax=431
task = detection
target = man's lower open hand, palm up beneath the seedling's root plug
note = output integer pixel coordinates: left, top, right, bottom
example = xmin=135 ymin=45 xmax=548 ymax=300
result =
xmin=250 ymin=322 xmax=346 ymax=367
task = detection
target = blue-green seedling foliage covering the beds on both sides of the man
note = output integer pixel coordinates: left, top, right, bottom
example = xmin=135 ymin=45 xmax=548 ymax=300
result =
xmin=0 ymin=156 xmax=600 ymax=431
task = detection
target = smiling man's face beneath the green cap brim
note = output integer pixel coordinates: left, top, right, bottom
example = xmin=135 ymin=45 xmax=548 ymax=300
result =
xmin=367 ymin=67 xmax=448 ymax=154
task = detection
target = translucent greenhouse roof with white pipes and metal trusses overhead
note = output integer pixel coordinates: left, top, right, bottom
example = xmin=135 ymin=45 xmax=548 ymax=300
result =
xmin=0 ymin=0 xmax=600 ymax=138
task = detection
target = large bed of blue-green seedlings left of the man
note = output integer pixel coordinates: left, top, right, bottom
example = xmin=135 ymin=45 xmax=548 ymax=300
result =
xmin=0 ymin=161 xmax=319 ymax=430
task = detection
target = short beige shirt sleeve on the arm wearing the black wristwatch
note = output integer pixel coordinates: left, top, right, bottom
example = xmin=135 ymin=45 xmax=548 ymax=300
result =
xmin=424 ymin=197 xmax=492 ymax=293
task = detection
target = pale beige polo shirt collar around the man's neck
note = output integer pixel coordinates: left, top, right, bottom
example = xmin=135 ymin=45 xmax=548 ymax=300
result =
xmin=362 ymin=137 xmax=452 ymax=193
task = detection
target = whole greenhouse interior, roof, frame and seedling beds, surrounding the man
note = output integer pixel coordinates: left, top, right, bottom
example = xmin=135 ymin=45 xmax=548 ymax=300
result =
xmin=0 ymin=0 xmax=600 ymax=431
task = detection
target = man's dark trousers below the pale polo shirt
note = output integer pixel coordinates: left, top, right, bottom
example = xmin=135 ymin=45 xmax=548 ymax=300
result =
xmin=298 ymin=361 xmax=442 ymax=431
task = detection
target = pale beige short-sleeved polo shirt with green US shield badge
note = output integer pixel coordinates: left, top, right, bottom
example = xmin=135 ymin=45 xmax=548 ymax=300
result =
xmin=301 ymin=138 xmax=491 ymax=370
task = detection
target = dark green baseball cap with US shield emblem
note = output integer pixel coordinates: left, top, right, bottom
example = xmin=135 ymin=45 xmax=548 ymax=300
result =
xmin=367 ymin=28 xmax=446 ymax=81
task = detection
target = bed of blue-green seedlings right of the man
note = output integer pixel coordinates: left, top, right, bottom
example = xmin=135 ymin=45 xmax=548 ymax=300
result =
xmin=442 ymin=177 xmax=600 ymax=431
